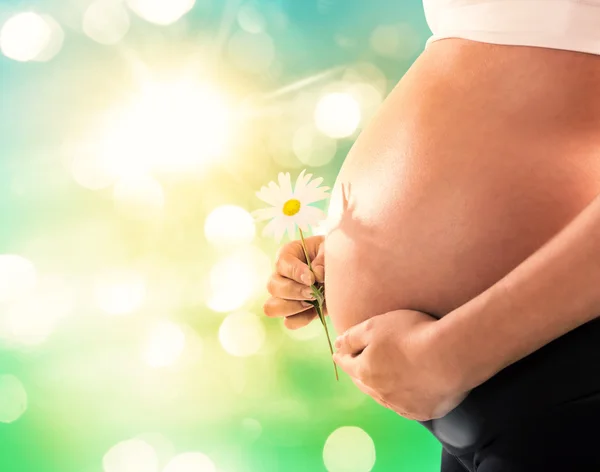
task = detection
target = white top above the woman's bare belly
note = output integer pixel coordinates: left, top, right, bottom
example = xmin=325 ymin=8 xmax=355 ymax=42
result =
xmin=423 ymin=0 xmax=600 ymax=54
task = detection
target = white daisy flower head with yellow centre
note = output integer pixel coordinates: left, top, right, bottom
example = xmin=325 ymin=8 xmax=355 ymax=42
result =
xmin=252 ymin=169 xmax=329 ymax=242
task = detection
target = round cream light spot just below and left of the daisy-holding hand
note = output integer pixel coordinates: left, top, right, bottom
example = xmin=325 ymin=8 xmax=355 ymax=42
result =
xmin=219 ymin=312 xmax=266 ymax=357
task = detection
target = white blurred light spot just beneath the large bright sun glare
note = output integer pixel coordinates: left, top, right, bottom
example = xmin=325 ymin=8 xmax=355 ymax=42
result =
xmin=113 ymin=176 xmax=165 ymax=219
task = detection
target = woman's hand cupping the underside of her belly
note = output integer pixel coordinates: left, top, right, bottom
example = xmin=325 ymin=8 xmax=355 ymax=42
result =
xmin=333 ymin=310 xmax=469 ymax=421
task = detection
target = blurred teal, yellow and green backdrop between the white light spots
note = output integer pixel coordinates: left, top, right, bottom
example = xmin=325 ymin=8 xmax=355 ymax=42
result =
xmin=0 ymin=0 xmax=441 ymax=472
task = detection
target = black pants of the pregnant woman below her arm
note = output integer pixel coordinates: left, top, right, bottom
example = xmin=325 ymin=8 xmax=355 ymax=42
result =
xmin=421 ymin=318 xmax=600 ymax=472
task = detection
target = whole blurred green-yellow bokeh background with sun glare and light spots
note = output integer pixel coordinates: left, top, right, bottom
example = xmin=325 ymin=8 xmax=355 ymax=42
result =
xmin=0 ymin=0 xmax=441 ymax=472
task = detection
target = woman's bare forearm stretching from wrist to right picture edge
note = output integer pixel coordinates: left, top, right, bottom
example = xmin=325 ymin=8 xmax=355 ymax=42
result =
xmin=435 ymin=190 xmax=600 ymax=389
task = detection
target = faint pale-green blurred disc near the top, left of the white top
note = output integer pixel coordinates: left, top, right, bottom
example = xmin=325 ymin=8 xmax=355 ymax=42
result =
xmin=228 ymin=31 xmax=275 ymax=72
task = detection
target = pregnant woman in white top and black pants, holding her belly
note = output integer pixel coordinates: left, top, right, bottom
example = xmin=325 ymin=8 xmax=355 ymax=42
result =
xmin=264 ymin=0 xmax=600 ymax=472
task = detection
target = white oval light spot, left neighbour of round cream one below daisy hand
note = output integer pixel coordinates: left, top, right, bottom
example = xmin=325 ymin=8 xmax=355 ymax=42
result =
xmin=144 ymin=321 xmax=185 ymax=367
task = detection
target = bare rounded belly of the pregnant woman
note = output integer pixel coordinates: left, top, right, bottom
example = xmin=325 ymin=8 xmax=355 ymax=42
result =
xmin=325 ymin=39 xmax=600 ymax=333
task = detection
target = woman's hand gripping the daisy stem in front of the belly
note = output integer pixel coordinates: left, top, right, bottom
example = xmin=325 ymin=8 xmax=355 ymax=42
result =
xmin=263 ymin=236 xmax=327 ymax=329
